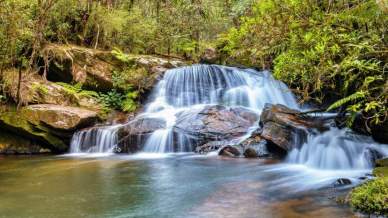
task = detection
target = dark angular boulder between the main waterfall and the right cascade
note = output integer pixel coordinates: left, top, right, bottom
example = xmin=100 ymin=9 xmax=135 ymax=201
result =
xmin=260 ymin=104 xmax=327 ymax=152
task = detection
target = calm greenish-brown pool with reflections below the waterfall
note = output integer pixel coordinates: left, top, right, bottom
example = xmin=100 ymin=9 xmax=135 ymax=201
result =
xmin=0 ymin=154 xmax=365 ymax=218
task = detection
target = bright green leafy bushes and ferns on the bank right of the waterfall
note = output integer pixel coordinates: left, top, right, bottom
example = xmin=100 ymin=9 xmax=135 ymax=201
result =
xmin=219 ymin=0 xmax=388 ymax=124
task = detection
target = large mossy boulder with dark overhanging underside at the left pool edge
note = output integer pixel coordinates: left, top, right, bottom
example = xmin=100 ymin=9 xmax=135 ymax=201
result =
xmin=0 ymin=104 xmax=98 ymax=153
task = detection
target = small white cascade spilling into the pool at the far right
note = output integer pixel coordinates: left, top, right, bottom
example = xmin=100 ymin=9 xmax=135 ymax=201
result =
xmin=287 ymin=128 xmax=388 ymax=170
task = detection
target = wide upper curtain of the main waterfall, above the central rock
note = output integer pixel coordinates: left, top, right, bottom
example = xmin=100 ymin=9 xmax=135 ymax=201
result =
xmin=146 ymin=65 xmax=298 ymax=113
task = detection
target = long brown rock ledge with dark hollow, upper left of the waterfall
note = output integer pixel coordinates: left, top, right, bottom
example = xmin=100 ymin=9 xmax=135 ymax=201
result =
xmin=44 ymin=44 xmax=184 ymax=91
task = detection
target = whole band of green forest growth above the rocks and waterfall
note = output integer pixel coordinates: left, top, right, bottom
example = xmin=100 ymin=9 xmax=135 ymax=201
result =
xmin=0 ymin=0 xmax=388 ymax=125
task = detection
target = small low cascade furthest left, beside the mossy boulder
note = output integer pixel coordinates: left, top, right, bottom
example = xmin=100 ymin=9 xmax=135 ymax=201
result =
xmin=70 ymin=125 xmax=121 ymax=153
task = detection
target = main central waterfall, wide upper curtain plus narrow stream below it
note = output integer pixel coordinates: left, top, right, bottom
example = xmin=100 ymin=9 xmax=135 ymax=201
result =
xmin=141 ymin=65 xmax=298 ymax=153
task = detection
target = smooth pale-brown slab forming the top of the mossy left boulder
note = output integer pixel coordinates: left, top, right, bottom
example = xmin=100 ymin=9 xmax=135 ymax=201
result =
xmin=24 ymin=104 xmax=98 ymax=130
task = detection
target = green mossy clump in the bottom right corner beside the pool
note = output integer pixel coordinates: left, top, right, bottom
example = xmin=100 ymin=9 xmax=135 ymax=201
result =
xmin=350 ymin=177 xmax=388 ymax=215
